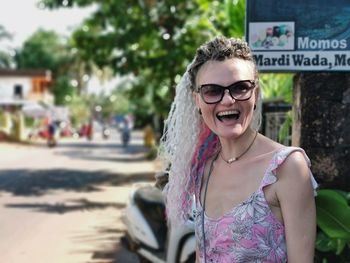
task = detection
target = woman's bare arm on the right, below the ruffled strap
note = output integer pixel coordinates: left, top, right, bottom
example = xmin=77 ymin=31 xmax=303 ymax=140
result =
xmin=276 ymin=152 xmax=316 ymax=263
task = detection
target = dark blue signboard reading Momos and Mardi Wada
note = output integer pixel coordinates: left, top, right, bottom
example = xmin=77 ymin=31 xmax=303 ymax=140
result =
xmin=246 ymin=0 xmax=350 ymax=72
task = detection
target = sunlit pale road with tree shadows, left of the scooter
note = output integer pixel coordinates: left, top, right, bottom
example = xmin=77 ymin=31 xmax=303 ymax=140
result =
xmin=0 ymin=133 xmax=156 ymax=263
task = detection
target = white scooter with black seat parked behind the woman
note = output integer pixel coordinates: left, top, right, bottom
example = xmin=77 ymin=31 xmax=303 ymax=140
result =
xmin=123 ymin=178 xmax=196 ymax=263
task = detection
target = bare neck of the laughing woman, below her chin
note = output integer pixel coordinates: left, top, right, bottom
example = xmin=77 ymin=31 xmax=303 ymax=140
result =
xmin=220 ymin=129 xmax=257 ymax=162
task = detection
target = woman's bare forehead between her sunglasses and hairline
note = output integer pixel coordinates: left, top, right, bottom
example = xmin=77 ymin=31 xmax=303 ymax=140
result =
xmin=196 ymin=58 xmax=255 ymax=86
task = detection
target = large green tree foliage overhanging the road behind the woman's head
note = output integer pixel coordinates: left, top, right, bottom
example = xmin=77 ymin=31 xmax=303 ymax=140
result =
xmin=41 ymin=0 xmax=244 ymax=131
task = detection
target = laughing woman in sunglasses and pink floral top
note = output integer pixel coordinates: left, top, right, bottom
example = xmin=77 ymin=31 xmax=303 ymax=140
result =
xmin=160 ymin=37 xmax=317 ymax=263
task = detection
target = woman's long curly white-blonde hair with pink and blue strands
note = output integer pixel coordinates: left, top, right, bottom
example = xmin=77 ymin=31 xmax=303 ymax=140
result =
xmin=159 ymin=36 xmax=261 ymax=225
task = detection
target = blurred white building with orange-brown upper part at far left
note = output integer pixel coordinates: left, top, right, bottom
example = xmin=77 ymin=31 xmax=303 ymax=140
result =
xmin=0 ymin=69 xmax=54 ymax=141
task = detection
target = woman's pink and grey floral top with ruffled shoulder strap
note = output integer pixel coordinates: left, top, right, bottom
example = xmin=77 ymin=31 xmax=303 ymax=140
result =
xmin=195 ymin=147 xmax=317 ymax=263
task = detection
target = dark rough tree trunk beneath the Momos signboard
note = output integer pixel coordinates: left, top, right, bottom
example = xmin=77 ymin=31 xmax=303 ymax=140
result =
xmin=292 ymin=72 xmax=350 ymax=191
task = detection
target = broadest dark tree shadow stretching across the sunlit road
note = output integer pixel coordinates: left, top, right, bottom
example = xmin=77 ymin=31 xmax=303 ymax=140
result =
xmin=0 ymin=169 xmax=154 ymax=196
